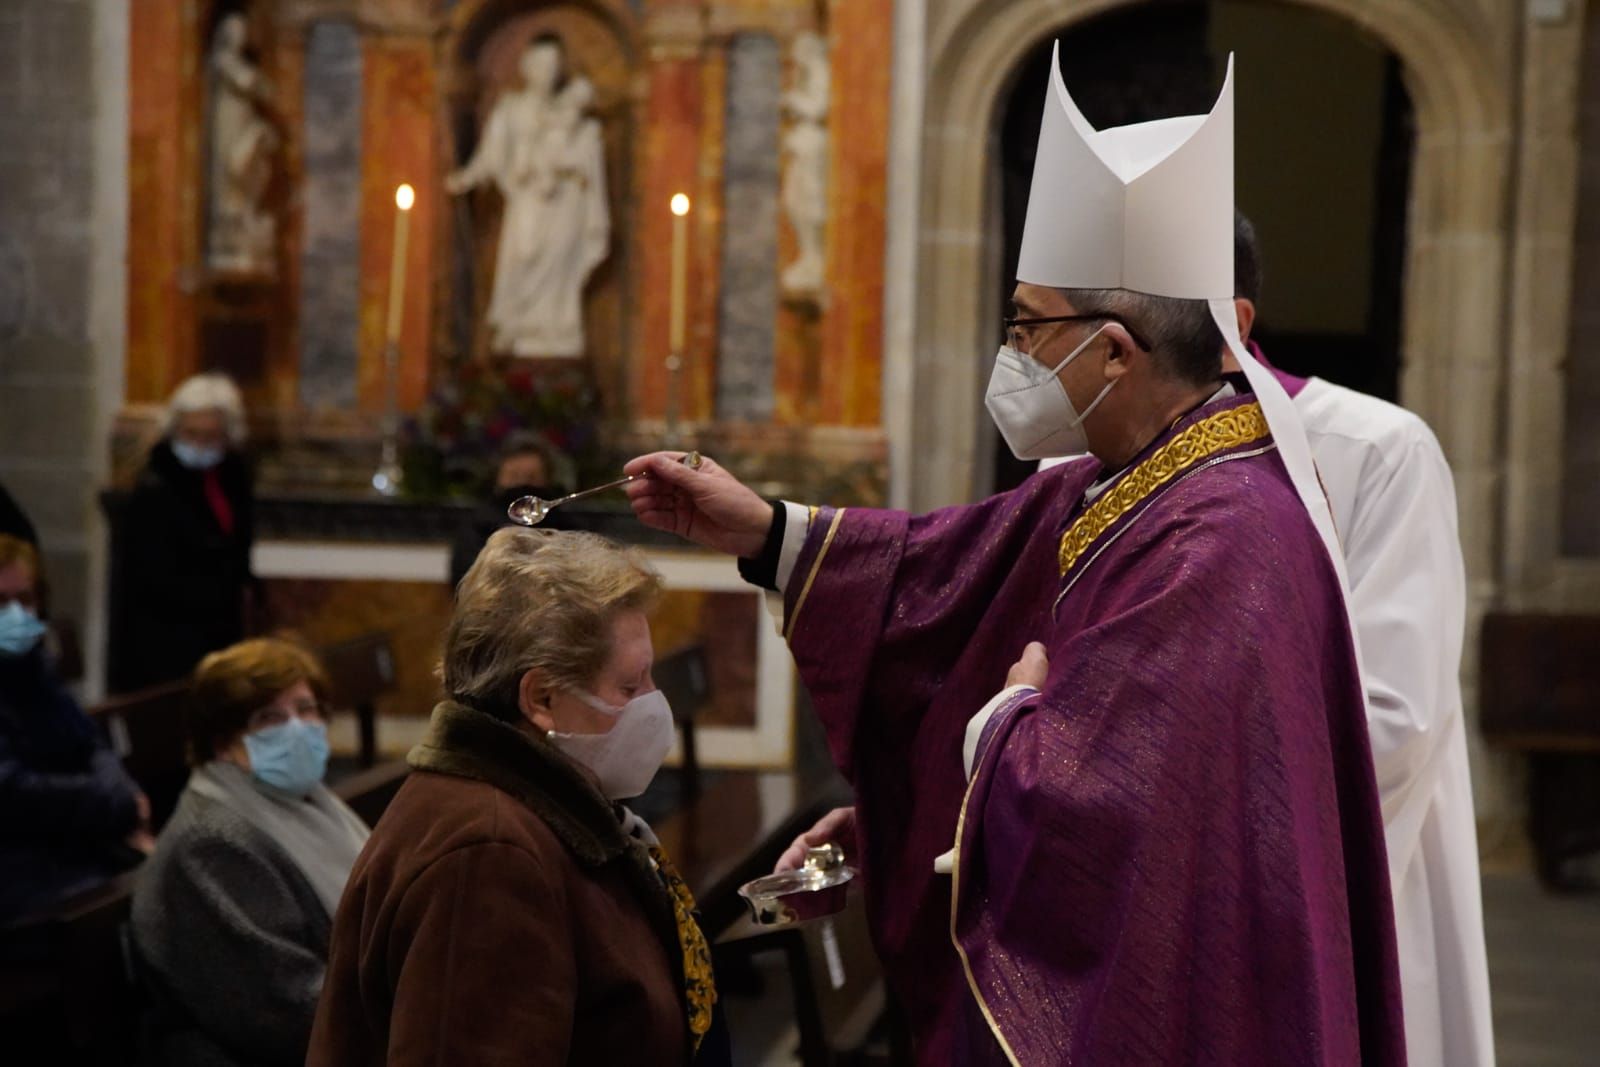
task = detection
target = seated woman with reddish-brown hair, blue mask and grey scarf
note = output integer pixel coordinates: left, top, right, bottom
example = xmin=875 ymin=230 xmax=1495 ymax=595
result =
xmin=133 ymin=638 xmax=368 ymax=1067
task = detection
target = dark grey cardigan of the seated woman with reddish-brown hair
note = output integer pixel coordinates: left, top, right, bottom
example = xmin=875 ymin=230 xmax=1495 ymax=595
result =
xmin=133 ymin=789 xmax=333 ymax=1067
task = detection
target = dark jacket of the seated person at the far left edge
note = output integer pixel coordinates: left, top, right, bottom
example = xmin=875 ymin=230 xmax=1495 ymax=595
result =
xmin=0 ymin=648 xmax=139 ymax=923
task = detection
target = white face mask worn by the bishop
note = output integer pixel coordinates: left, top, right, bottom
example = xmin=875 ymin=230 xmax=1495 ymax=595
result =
xmin=984 ymin=326 xmax=1120 ymax=459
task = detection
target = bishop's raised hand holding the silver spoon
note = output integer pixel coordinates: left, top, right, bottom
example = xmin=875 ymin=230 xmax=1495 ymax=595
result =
xmin=622 ymin=453 xmax=773 ymax=557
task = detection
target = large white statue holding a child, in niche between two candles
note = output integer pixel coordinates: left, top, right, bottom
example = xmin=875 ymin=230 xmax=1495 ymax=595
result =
xmin=445 ymin=35 xmax=611 ymax=358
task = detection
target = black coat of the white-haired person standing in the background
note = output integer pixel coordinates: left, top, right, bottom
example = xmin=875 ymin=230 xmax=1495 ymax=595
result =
xmin=109 ymin=440 xmax=254 ymax=693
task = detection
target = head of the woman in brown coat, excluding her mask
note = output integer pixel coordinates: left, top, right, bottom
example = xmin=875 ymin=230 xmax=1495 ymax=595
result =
xmin=440 ymin=528 xmax=661 ymax=733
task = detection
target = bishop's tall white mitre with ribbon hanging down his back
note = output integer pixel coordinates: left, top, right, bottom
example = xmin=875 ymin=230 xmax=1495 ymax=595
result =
xmin=1016 ymin=43 xmax=1349 ymax=592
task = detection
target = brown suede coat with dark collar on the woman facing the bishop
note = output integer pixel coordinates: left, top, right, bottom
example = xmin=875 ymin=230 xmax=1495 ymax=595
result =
xmin=307 ymin=702 xmax=690 ymax=1067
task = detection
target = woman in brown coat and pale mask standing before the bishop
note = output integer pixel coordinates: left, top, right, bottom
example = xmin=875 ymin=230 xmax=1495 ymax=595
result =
xmin=307 ymin=528 xmax=726 ymax=1067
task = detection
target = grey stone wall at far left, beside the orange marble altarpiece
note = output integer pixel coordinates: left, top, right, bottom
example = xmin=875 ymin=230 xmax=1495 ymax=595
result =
xmin=0 ymin=0 xmax=126 ymax=655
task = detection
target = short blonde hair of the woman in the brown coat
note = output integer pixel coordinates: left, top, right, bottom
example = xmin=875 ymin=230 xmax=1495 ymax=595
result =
xmin=440 ymin=526 xmax=661 ymax=717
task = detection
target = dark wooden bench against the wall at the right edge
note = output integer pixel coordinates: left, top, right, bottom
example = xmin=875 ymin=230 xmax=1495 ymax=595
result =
xmin=1478 ymin=613 xmax=1600 ymax=888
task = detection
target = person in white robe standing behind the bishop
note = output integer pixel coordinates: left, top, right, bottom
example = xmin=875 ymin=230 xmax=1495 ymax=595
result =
xmin=1235 ymin=216 xmax=1494 ymax=1067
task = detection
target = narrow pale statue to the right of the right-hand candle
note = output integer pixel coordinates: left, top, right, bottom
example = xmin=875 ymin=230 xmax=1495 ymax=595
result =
xmin=782 ymin=32 xmax=829 ymax=298
